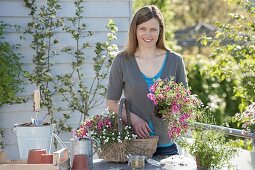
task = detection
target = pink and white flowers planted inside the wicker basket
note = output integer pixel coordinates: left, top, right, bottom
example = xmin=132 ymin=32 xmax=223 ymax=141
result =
xmin=75 ymin=111 xmax=137 ymax=145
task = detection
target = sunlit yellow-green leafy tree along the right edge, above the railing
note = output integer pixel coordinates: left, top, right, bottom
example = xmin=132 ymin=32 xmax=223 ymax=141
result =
xmin=201 ymin=0 xmax=255 ymax=111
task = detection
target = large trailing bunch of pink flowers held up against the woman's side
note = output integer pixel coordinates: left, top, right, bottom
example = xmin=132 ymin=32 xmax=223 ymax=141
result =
xmin=147 ymin=78 xmax=201 ymax=140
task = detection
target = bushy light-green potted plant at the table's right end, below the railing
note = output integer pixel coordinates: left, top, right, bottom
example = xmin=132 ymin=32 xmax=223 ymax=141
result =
xmin=186 ymin=129 xmax=237 ymax=169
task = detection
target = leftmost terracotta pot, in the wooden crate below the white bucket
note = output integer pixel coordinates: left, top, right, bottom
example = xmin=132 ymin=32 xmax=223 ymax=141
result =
xmin=27 ymin=149 xmax=46 ymax=164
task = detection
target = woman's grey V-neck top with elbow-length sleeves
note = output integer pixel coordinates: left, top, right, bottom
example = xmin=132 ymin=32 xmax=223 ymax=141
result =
xmin=107 ymin=51 xmax=187 ymax=145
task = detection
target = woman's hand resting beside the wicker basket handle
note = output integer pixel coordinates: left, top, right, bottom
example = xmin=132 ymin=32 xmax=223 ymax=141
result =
xmin=130 ymin=113 xmax=152 ymax=138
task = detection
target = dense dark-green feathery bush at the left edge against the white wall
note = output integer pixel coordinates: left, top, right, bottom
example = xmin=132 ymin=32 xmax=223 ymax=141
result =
xmin=0 ymin=22 xmax=24 ymax=106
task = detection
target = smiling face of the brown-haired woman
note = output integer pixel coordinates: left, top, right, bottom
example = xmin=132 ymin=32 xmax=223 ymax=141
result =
xmin=136 ymin=18 xmax=160 ymax=48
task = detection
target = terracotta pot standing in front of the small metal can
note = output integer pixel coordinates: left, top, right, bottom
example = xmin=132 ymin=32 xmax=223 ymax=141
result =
xmin=72 ymin=154 xmax=89 ymax=170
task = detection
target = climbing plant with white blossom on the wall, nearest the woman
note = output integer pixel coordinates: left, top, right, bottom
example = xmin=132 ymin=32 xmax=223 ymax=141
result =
xmin=58 ymin=0 xmax=118 ymax=123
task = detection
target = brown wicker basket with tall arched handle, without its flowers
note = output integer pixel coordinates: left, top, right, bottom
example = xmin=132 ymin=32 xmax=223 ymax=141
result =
xmin=97 ymin=98 xmax=158 ymax=162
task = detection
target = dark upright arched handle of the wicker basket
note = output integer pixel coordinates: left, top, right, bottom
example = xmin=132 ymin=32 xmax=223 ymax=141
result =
xmin=118 ymin=98 xmax=131 ymax=137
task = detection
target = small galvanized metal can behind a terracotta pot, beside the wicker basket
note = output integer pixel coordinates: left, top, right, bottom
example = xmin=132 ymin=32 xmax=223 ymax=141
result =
xmin=71 ymin=138 xmax=96 ymax=169
